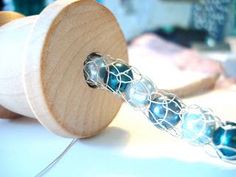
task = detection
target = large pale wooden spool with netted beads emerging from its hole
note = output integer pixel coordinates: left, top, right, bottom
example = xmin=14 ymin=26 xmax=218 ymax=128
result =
xmin=0 ymin=0 xmax=128 ymax=138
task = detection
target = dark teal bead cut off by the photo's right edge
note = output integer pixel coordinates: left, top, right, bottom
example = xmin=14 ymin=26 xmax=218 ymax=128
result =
xmin=213 ymin=123 xmax=236 ymax=160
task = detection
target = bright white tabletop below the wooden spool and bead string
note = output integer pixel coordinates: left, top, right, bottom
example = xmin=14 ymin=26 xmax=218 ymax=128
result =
xmin=0 ymin=101 xmax=236 ymax=177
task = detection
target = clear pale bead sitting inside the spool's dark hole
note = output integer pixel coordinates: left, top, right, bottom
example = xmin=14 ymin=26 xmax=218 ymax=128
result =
xmin=84 ymin=55 xmax=106 ymax=87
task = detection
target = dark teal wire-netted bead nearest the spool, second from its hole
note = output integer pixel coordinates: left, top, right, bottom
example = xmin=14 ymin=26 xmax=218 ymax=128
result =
xmin=104 ymin=62 xmax=133 ymax=92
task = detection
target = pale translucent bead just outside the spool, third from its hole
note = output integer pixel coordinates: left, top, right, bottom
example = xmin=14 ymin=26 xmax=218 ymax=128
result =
xmin=124 ymin=78 xmax=156 ymax=107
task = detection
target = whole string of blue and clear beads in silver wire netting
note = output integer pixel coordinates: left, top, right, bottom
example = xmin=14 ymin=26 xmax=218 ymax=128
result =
xmin=84 ymin=53 xmax=236 ymax=163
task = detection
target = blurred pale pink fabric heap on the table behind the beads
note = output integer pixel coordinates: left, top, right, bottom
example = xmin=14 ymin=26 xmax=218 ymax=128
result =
xmin=129 ymin=33 xmax=236 ymax=88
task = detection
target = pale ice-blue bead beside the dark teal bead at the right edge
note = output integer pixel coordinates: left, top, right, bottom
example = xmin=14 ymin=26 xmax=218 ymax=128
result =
xmin=181 ymin=106 xmax=216 ymax=144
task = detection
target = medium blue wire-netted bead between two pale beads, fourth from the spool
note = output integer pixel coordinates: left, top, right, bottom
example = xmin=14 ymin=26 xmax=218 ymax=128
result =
xmin=149 ymin=96 xmax=182 ymax=129
